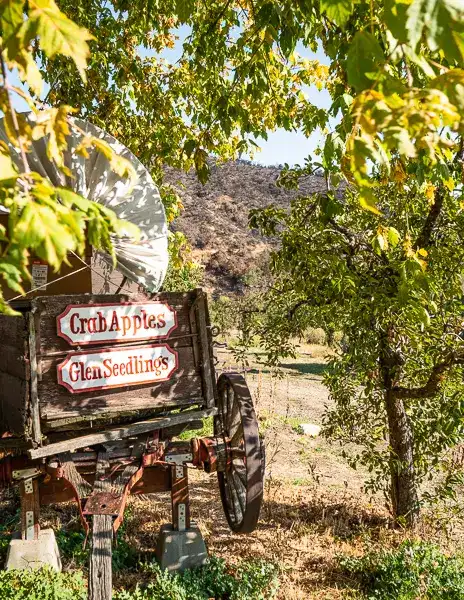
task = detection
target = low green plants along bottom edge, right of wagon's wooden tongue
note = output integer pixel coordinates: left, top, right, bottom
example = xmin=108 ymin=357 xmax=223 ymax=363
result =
xmin=114 ymin=557 xmax=278 ymax=600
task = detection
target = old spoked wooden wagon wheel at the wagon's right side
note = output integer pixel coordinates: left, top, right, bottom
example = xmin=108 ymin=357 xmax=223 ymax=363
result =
xmin=214 ymin=373 xmax=264 ymax=533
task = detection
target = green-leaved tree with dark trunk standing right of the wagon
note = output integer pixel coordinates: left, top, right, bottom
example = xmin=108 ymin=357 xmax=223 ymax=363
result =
xmin=245 ymin=180 xmax=464 ymax=524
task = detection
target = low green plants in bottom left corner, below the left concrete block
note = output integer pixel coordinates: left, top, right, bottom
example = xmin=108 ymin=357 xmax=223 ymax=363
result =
xmin=0 ymin=568 xmax=87 ymax=600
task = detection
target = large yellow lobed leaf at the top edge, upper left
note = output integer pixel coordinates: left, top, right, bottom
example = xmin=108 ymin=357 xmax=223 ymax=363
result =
xmin=24 ymin=0 xmax=95 ymax=81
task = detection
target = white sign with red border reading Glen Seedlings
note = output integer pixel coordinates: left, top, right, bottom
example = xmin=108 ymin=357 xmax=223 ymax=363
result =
xmin=58 ymin=344 xmax=179 ymax=394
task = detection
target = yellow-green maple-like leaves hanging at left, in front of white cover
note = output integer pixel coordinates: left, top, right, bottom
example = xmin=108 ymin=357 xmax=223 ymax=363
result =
xmin=0 ymin=0 xmax=136 ymax=312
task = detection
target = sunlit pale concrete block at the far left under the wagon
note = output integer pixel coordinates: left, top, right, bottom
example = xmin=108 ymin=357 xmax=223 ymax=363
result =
xmin=5 ymin=529 xmax=61 ymax=571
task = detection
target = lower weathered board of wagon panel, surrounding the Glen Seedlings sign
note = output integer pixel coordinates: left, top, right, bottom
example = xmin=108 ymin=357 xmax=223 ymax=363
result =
xmin=38 ymin=348 xmax=202 ymax=421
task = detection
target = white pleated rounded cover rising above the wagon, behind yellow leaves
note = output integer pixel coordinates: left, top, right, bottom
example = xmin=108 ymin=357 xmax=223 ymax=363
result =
xmin=0 ymin=115 xmax=168 ymax=292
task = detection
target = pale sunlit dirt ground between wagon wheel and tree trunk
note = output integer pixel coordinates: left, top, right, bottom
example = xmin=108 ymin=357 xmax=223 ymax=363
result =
xmin=218 ymin=345 xmax=365 ymax=493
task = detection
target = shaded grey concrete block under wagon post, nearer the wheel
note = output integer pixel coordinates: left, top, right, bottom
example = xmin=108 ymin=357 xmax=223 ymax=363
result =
xmin=156 ymin=523 xmax=208 ymax=571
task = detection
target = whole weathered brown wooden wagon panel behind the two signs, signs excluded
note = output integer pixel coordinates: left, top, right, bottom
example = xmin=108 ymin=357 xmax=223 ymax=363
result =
xmin=34 ymin=292 xmax=206 ymax=431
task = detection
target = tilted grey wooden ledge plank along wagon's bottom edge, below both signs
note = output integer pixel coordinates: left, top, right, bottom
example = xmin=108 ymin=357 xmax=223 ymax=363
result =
xmin=28 ymin=408 xmax=217 ymax=460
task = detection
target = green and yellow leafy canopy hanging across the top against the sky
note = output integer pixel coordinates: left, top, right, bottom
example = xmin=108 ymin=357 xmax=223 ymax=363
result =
xmin=43 ymin=0 xmax=464 ymax=211
